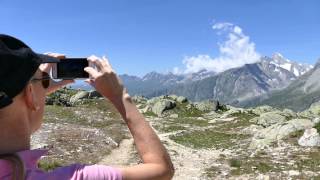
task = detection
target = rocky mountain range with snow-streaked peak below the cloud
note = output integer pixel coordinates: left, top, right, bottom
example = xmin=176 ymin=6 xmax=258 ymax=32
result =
xmin=71 ymin=53 xmax=318 ymax=110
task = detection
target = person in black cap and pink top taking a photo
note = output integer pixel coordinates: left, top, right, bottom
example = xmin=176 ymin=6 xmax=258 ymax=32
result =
xmin=0 ymin=35 xmax=174 ymax=180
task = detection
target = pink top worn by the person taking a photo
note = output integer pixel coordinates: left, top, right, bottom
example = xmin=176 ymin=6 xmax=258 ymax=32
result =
xmin=0 ymin=149 xmax=122 ymax=180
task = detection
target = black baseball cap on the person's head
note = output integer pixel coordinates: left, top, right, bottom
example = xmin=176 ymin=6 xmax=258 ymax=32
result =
xmin=0 ymin=34 xmax=59 ymax=109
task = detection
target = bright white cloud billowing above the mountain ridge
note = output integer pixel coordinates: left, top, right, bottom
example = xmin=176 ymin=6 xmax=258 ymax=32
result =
xmin=173 ymin=22 xmax=260 ymax=74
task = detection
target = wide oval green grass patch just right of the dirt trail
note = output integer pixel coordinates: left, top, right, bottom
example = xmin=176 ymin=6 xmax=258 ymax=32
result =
xmin=170 ymin=130 xmax=249 ymax=149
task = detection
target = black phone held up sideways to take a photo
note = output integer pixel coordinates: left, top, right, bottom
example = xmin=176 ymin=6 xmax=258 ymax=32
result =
xmin=52 ymin=58 xmax=90 ymax=79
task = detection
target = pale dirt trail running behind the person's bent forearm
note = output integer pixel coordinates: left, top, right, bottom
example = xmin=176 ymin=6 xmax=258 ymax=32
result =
xmin=99 ymin=127 xmax=226 ymax=180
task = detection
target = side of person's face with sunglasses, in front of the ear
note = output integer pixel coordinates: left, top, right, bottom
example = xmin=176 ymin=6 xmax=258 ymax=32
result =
xmin=31 ymin=70 xmax=48 ymax=133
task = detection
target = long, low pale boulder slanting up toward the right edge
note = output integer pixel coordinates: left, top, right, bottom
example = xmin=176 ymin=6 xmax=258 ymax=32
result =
xmin=249 ymin=119 xmax=315 ymax=149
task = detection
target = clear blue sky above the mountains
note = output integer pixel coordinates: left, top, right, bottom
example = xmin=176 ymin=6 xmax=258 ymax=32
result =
xmin=0 ymin=0 xmax=320 ymax=76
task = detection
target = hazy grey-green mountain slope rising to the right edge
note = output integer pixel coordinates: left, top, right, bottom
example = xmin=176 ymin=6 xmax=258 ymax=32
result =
xmin=241 ymin=59 xmax=320 ymax=111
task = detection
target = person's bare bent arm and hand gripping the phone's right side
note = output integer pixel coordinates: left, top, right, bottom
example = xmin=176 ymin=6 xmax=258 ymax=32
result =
xmin=85 ymin=57 xmax=174 ymax=179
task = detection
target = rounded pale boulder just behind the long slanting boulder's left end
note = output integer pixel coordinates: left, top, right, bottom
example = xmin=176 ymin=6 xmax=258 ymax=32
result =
xmin=252 ymin=112 xmax=286 ymax=127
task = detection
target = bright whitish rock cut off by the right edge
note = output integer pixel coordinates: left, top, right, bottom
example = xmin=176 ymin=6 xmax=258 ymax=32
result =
xmin=298 ymin=128 xmax=320 ymax=147
